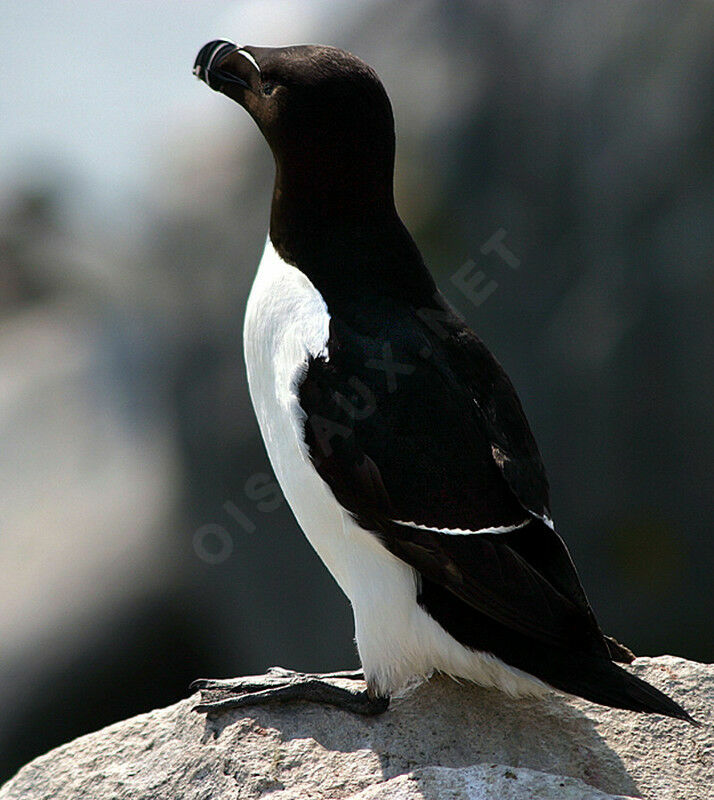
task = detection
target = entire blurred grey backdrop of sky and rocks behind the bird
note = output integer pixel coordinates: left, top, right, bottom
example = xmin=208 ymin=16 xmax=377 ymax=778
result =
xmin=0 ymin=0 xmax=714 ymax=780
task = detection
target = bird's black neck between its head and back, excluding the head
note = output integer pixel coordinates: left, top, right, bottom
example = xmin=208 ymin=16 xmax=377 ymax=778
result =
xmin=270 ymin=159 xmax=435 ymax=304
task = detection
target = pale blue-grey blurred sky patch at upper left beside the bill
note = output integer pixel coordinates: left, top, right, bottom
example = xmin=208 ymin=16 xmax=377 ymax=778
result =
xmin=0 ymin=0 xmax=364 ymax=216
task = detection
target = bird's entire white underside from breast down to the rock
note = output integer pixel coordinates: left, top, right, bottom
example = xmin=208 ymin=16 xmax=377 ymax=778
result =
xmin=244 ymin=239 xmax=543 ymax=694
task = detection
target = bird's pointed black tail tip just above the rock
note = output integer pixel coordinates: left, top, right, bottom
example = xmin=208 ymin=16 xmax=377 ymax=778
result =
xmin=556 ymin=659 xmax=701 ymax=725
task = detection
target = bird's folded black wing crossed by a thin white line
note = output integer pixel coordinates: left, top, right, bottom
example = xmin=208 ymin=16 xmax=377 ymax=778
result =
xmin=297 ymin=300 xmax=605 ymax=652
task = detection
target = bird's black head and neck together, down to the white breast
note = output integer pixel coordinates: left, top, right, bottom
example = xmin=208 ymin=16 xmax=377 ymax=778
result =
xmin=193 ymin=40 xmax=428 ymax=305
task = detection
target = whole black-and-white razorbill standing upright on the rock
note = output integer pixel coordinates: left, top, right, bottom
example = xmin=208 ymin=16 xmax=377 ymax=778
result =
xmin=192 ymin=39 xmax=697 ymax=724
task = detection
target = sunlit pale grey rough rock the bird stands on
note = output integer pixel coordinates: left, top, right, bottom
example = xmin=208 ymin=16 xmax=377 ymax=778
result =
xmin=0 ymin=656 xmax=714 ymax=800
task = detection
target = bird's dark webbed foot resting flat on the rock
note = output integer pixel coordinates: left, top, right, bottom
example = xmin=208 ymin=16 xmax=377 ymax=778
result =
xmin=191 ymin=667 xmax=389 ymax=716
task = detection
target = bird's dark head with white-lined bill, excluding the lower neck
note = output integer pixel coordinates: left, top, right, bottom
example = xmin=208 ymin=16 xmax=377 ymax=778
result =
xmin=193 ymin=40 xmax=394 ymax=211
